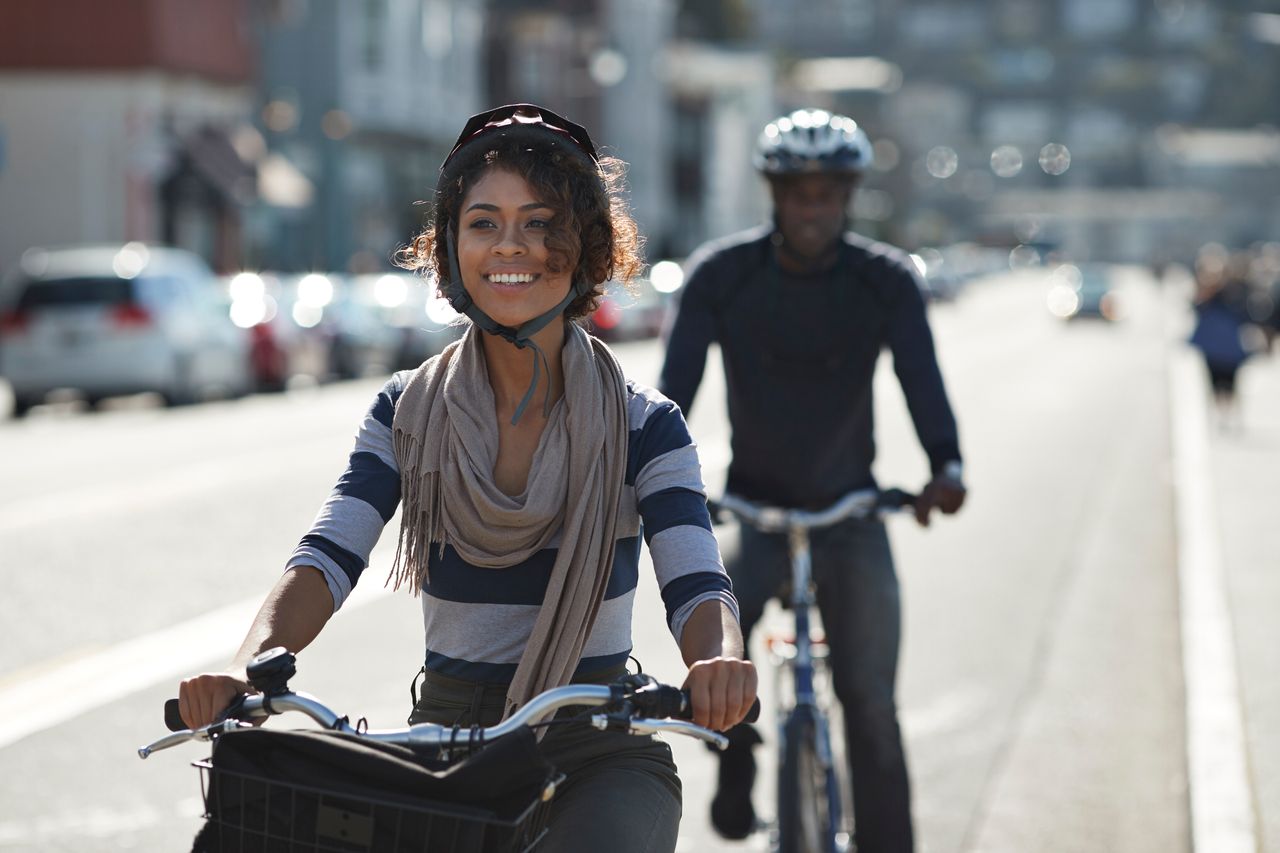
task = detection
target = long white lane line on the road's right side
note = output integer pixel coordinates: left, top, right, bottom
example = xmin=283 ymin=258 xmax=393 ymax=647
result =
xmin=1169 ymin=345 xmax=1260 ymax=853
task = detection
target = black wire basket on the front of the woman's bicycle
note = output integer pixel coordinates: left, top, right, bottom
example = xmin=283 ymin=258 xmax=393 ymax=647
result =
xmin=193 ymin=760 xmax=564 ymax=853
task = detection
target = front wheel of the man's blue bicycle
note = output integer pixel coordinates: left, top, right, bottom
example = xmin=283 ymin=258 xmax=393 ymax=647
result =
xmin=778 ymin=708 xmax=836 ymax=853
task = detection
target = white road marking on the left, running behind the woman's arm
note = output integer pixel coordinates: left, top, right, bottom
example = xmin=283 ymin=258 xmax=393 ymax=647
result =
xmin=0 ymin=568 xmax=389 ymax=749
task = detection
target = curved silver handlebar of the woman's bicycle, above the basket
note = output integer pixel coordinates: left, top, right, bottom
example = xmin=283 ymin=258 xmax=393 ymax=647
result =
xmin=138 ymin=676 xmax=760 ymax=758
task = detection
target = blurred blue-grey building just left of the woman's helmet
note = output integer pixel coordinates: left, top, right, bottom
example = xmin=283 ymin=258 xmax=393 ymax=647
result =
xmin=246 ymin=0 xmax=485 ymax=272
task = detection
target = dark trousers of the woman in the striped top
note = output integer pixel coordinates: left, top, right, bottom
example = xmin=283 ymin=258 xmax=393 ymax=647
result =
xmin=410 ymin=671 xmax=681 ymax=853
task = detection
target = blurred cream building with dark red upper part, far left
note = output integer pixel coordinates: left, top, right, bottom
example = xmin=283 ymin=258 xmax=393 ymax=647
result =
xmin=0 ymin=0 xmax=257 ymax=268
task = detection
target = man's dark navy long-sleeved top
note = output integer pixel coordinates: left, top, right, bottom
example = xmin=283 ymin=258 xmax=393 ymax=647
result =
xmin=660 ymin=222 xmax=960 ymax=508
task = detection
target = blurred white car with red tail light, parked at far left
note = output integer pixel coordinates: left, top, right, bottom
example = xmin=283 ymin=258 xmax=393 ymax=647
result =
xmin=0 ymin=243 xmax=250 ymax=415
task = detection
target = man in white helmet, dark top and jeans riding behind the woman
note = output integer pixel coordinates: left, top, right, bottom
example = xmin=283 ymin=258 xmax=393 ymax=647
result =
xmin=660 ymin=110 xmax=965 ymax=853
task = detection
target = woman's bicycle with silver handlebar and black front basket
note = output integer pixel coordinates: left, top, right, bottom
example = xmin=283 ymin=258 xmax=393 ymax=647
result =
xmin=138 ymin=648 xmax=759 ymax=853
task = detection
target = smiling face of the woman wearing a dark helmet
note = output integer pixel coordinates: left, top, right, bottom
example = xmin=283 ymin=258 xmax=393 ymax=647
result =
xmin=458 ymin=168 xmax=576 ymax=327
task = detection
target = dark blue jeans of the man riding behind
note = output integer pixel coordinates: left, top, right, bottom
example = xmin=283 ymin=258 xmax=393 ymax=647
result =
xmin=728 ymin=520 xmax=913 ymax=853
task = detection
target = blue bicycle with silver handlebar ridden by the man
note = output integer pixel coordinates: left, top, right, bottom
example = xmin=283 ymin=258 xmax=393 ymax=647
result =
xmin=710 ymin=489 xmax=915 ymax=853
